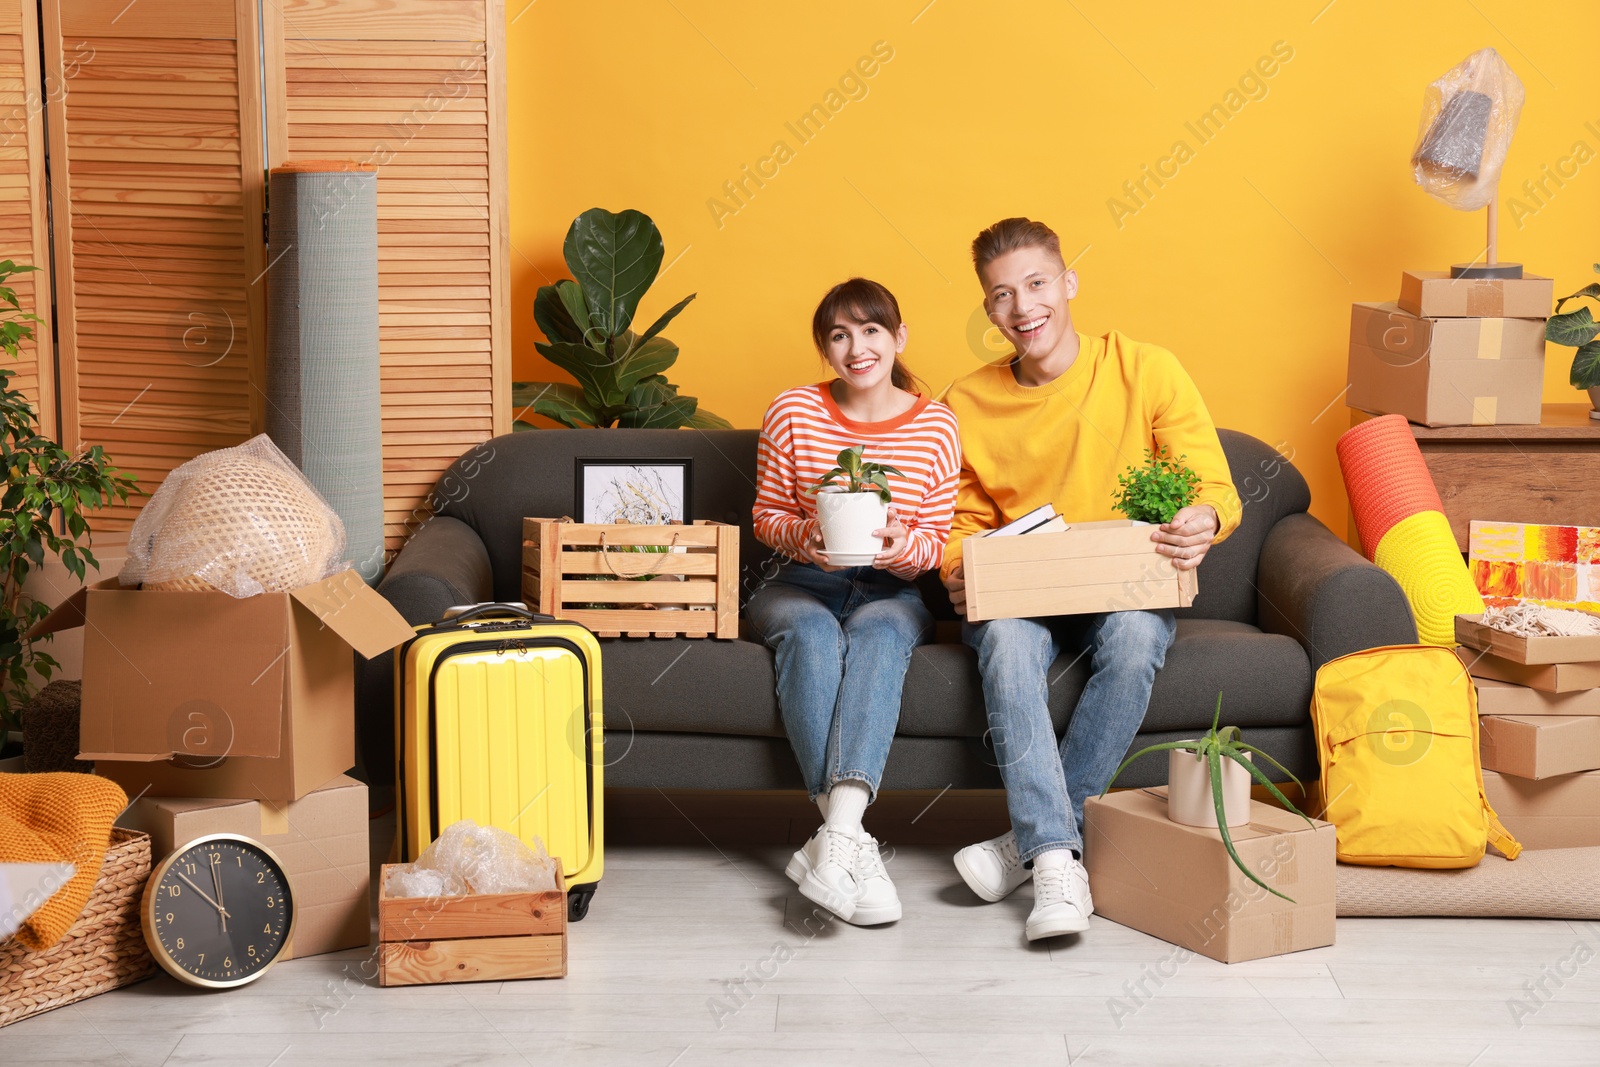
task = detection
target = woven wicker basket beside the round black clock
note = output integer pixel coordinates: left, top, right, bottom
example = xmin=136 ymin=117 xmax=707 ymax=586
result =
xmin=0 ymin=827 xmax=155 ymax=1027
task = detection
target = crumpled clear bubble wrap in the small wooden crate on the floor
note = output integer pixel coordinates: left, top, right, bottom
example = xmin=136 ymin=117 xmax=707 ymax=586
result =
xmin=384 ymin=819 xmax=557 ymax=897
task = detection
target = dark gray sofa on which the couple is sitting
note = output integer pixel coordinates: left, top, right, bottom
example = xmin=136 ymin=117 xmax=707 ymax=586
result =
xmin=358 ymin=430 xmax=1416 ymax=789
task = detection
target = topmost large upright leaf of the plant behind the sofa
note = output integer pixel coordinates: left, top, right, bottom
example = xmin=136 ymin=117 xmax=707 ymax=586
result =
xmin=562 ymin=208 xmax=664 ymax=336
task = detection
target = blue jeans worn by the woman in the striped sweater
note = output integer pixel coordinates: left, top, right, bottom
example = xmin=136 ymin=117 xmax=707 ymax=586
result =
xmin=744 ymin=561 xmax=933 ymax=800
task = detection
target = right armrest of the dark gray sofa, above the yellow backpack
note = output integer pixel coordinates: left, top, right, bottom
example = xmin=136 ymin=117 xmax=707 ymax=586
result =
xmin=1256 ymin=512 xmax=1416 ymax=673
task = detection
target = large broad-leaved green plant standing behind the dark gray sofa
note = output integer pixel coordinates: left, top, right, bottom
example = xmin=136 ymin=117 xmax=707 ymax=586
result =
xmin=510 ymin=208 xmax=731 ymax=430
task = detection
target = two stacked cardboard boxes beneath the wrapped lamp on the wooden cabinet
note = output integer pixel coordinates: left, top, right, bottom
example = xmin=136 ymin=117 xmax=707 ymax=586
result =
xmin=1346 ymin=270 xmax=1555 ymax=426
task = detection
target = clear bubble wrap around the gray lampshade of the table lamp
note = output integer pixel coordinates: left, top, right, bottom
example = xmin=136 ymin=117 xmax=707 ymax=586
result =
xmin=1411 ymin=48 xmax=1523 ymax=211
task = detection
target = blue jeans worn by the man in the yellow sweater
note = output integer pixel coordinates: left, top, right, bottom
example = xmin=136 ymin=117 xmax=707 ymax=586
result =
xmin=962 ymin=611 xmax=1178 ymax=861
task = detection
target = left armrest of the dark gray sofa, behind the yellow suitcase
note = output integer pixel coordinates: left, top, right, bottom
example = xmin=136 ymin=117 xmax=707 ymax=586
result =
xmin=355 ymin=515 xmax=494 ymax=787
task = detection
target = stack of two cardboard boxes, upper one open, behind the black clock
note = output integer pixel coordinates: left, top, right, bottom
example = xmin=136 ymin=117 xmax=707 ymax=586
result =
xmin=30 ymin=571 xmax=413 ymax=957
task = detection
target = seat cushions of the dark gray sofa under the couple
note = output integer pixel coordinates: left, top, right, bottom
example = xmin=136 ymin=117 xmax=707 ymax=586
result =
xmin=600 ymin=619 xmax=1310 ymax=737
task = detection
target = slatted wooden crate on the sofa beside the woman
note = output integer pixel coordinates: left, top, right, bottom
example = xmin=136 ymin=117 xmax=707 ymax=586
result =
xmin=522 ymin=518 xmax=739 ymax=638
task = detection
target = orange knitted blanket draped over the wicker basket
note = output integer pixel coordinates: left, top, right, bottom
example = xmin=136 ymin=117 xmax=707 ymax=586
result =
xmin=0 ymin=773 xmax=128 ymax=950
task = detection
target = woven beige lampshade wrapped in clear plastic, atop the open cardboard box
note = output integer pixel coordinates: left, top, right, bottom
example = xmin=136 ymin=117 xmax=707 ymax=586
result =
xmin=118 ymin=434 xmax=344 ymax=597
